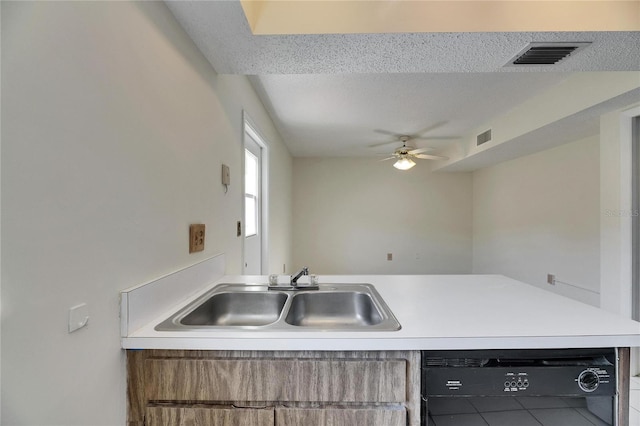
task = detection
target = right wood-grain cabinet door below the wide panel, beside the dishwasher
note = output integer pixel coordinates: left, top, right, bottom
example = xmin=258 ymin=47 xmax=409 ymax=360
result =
xmin=276 ymin=407 xmax=407 ymax=426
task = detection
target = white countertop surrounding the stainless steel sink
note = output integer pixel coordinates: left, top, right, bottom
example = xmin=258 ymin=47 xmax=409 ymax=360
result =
xmin=122 ymin=275 xmax=640 ymax=350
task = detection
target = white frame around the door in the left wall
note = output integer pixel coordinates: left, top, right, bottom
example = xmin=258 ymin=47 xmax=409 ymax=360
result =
xmin=240 ymin=111 xmax=269 ymax=275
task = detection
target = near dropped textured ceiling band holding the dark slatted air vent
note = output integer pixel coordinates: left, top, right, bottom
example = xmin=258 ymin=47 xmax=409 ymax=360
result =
xmin=167 ymin=0 xmax=640 ymax=75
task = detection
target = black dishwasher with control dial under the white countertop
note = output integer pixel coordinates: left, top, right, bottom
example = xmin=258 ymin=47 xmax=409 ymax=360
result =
xmin=421 ymin=348 xmax=617 ymax=426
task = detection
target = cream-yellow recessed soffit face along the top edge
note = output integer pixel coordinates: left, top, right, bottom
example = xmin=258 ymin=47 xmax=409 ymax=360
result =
xmin=241 ymin=0 xmax=640 ymax=35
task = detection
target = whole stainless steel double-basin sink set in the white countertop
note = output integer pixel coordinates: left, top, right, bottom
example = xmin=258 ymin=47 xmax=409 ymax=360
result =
xmin=155 ymin=284 xmax=400 ymax=331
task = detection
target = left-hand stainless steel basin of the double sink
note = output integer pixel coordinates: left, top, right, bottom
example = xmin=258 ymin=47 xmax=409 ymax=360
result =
xmin=180 ymin=292 xmax=287 ymax=326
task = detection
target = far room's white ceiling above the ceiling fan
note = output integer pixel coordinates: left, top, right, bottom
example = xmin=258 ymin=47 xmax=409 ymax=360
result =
xmin=248 ymin=73 xmax=566 ymax=156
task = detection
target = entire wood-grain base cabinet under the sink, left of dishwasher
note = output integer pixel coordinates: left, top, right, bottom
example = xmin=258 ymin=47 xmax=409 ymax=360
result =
xmin=127 ymin=350 xmax=420 ymax=426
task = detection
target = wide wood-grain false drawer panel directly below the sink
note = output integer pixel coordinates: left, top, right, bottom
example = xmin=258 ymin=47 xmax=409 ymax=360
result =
xmin=144 ymin=359 xmax=407 ymax=403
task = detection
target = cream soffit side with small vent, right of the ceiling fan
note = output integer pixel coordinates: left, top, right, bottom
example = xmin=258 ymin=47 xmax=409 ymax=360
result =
xmin=435 ymin=71 xmax=640 ymax=171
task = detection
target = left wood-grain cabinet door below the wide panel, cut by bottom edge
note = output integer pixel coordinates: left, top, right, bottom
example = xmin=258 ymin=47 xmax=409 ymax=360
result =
xmin=145 ymin=406 xmax=274 ymax=426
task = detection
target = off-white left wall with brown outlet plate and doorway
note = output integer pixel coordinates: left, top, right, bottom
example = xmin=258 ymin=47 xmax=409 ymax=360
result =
xmin=1 ymin=2 xmax=292 ymax=425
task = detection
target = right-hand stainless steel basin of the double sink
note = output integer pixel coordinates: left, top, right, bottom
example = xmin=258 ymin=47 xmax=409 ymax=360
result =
xmin=285 ymin=291 xmax=383 ymax=328
